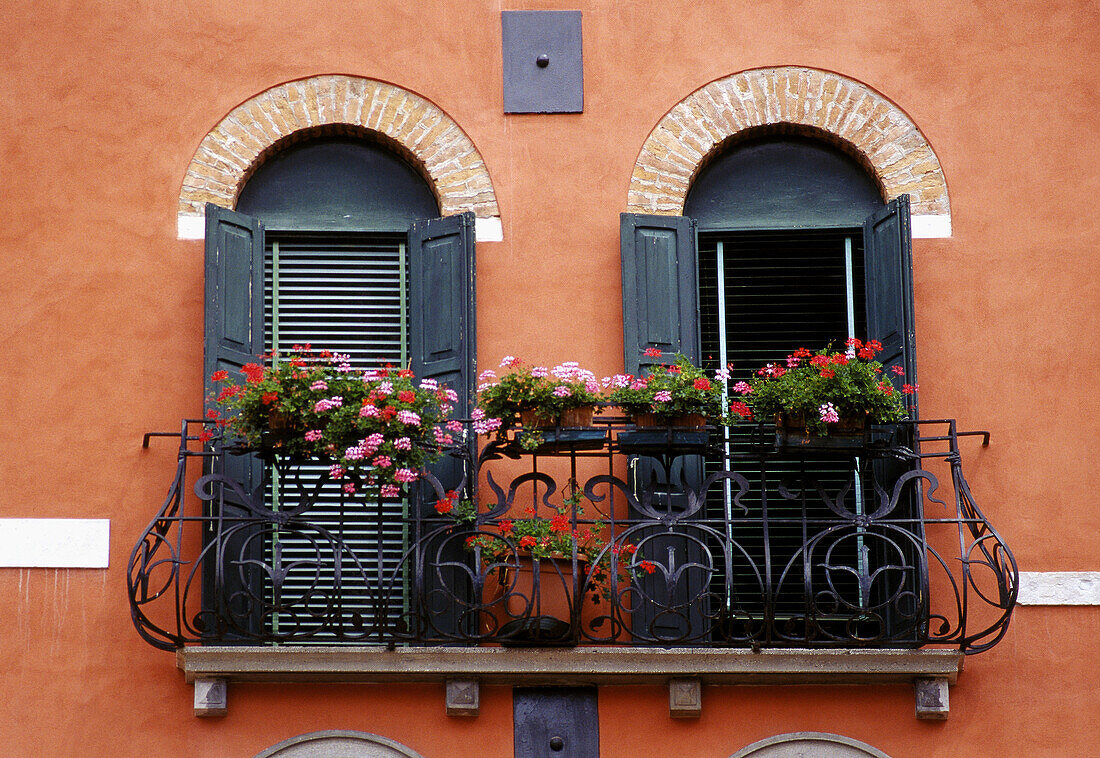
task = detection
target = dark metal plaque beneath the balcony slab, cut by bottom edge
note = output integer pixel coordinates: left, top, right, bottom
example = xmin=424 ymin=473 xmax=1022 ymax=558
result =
xmin=512 ymin=686 xmax=600 ymax=758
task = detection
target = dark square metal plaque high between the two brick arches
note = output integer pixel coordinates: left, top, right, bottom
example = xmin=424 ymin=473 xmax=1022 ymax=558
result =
xmin=501 ymin=11 xmax=584 ymax=113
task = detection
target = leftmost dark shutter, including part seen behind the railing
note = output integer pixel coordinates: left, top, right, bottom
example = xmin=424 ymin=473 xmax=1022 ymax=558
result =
xmin=202 ymin=204 xmax=264 ymax=640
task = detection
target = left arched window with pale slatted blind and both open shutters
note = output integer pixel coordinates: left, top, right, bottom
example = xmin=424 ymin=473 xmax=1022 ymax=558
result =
xmin=204 ymin=135 xmax=474 ymax=633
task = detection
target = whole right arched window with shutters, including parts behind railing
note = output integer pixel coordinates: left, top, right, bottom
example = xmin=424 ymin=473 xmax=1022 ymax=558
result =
xmin=622 ymin=131 xmax=916 ymax=638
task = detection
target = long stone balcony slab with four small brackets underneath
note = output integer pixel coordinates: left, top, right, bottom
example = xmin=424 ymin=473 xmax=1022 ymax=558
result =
xmin=176 ymin=647 xmax=964 ymax=719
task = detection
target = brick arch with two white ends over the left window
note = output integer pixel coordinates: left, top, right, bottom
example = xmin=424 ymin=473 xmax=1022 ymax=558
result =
xmin=178 ymin=75 xmax=501 ymax=239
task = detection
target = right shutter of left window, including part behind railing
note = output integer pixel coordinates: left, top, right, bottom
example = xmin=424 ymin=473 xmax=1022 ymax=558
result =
xmin=409 ymin=212 xmax=476 ymax=635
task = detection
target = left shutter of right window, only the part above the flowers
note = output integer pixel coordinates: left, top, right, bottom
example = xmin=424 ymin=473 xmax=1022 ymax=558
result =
xmin=620 ymin=213 xmax=700 ymax=374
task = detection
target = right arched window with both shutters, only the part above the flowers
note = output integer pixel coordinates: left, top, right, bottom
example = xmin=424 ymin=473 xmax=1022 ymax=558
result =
xmin=623 ymin=129 xmax=915 ymax=387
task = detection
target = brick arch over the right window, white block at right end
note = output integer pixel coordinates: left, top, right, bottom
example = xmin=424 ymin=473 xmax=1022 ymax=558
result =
xmin=627 ymin=66 xmax=950 ymax=237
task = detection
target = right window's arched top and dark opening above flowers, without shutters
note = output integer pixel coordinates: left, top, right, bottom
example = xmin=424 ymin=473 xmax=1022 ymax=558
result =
xmin=684 ymin=136 xmax=884 ymax=372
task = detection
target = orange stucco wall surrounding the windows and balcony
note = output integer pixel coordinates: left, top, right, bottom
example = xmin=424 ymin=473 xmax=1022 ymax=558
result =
xmin=0 ymin=0 xmax=1100 ymax=757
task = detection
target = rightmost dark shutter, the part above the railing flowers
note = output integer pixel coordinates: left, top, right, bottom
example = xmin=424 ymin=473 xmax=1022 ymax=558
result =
xmin=864 ymin=195 xmax=917 ymax=419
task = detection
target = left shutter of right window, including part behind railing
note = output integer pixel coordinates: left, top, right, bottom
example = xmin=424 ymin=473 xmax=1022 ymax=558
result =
xmin=620 ymin=213 xmax=708 ymax=642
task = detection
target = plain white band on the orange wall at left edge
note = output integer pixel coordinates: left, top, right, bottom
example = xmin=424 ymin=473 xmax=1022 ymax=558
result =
xmin=0 ymin=518 xmax=111 ymax=569
